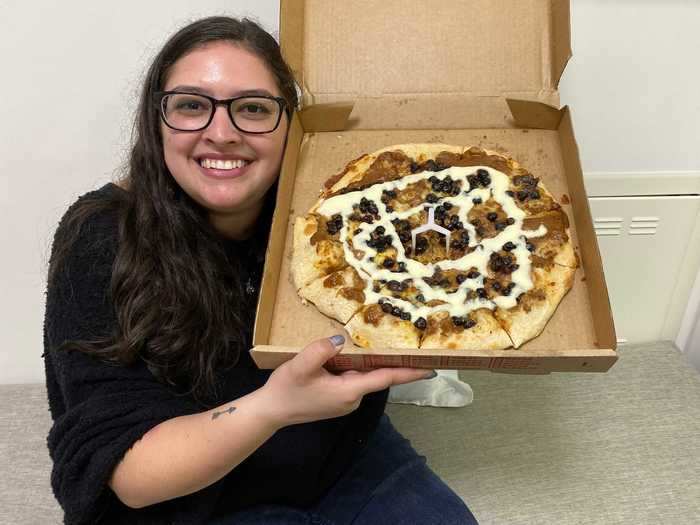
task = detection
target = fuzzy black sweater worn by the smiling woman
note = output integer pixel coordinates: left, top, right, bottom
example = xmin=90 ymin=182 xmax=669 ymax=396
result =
xmin=44 ymin=184 xmax=388 ymax=525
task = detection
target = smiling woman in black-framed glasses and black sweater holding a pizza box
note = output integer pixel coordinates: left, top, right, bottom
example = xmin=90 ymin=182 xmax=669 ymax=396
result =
xmin=44 ymin=17 xmax=473 ymax=524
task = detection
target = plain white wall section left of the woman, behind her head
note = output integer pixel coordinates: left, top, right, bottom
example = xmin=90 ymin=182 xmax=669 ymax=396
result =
xmin=0 ymin=0 xmax=279 ymax=384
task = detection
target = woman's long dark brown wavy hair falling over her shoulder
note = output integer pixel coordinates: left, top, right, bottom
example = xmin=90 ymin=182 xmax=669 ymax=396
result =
xmin=49 ymin=17 xmax=298 ymax=400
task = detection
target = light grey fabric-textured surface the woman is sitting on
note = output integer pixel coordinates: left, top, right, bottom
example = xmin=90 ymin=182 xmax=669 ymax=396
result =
xmin=5 ymin=343 xmax=700 ymax=525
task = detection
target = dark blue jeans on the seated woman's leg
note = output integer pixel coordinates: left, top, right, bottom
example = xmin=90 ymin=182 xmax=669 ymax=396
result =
xmin=212 ymin=414 xmax=477 ymax=525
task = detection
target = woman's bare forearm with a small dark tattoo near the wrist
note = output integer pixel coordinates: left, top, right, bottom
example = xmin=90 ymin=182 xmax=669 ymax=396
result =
xmin=109 ymin=390 xmax=282 ymax=508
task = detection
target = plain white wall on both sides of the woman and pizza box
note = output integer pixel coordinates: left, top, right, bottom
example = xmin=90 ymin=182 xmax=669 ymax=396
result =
xmin=0 ymin=0 xmax=700 ymax=384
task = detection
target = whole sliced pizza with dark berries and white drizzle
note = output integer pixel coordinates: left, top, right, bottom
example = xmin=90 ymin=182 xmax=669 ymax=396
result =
xmin=291 ymin=144 xmax=578 ymax=350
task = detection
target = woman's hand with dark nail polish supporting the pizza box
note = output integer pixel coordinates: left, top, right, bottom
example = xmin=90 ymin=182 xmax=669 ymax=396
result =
xmin=258 ymin=336 xmax=434 ymax=426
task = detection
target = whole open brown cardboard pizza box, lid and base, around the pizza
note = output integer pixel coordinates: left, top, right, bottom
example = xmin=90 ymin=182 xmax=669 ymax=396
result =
xmin=251 ymin=0 xmax=617 ymax=373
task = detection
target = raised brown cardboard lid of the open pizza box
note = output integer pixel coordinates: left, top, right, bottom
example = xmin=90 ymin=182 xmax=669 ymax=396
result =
xmin=280 ymin=0 xmax=571 ymax=129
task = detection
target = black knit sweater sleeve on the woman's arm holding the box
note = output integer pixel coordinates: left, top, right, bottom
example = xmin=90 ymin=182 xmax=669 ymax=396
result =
xmin=44 ymin=189 xmax=218 ymax=524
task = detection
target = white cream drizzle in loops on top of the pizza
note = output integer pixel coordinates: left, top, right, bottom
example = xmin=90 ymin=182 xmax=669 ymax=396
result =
xmin=318 ymin=166 xmax=547 ymax=320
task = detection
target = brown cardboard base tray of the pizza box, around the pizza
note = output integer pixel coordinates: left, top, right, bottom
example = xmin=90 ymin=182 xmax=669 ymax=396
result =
xmin=251 ymin=101 xmax=617 ymax=373
